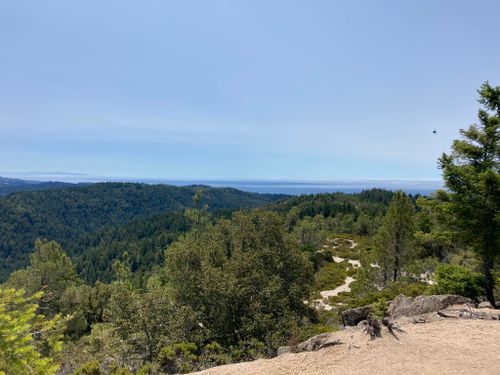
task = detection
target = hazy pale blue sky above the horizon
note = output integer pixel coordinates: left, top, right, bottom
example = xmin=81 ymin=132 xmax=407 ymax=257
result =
xmin=0 ymin=0 xmax=500 ymax=179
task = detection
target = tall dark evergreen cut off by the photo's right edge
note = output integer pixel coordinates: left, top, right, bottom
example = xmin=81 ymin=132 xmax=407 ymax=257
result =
xmin=439 ymin=82 xmax=500 ymax=306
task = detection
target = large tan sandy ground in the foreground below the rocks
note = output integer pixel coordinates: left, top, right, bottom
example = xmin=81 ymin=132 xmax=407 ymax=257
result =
xmin=191 ymin=319 xmax=500 ymax=375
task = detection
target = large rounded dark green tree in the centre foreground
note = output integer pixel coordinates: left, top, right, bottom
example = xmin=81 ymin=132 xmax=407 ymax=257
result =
xmin=166 ymin=211 xmax=312 ymax=349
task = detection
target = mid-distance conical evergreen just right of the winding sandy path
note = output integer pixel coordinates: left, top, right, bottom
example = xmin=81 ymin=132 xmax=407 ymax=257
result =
xmin=375 ymin=191 xmax=415 ymax=284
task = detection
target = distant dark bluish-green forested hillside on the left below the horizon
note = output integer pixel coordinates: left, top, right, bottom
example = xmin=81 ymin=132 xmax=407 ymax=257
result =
xmin=0 ymin=183 xmax=282 ymax=280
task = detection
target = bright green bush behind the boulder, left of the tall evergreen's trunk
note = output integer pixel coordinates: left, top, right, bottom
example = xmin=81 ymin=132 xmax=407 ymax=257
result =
xmin=432 ymin=264 xmax=483 ymax=299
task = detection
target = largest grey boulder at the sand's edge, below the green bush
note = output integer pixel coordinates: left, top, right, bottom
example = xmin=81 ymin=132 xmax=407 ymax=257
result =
xmin=388 ymin=294 xmax=473 ymax=319
